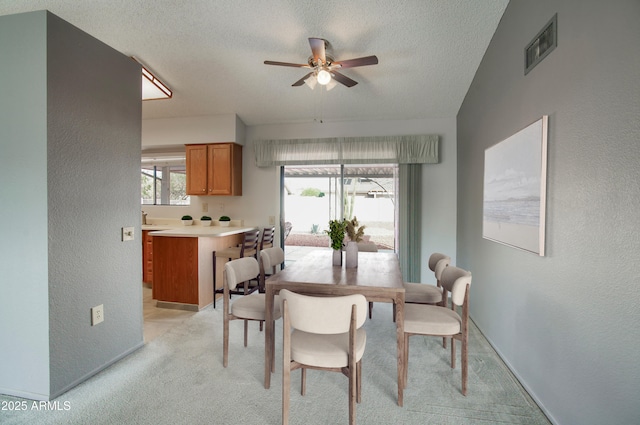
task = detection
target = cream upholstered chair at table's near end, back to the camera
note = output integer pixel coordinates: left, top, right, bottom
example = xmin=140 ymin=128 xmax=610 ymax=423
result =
xmin=280 ymin=289 xmax=367 ymax=425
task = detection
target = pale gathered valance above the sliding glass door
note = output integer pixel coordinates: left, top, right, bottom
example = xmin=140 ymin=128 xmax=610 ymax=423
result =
xmin=254 ymin=135 xmax=439 ymax=167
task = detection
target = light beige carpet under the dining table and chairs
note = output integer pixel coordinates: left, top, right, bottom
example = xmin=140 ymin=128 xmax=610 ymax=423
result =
xmin=0 ymin=303 xmax=549 ymax=425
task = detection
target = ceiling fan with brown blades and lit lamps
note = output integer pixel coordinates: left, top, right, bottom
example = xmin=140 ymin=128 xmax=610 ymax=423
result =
xmin=264 ymin=37 xmax=378 ymax=90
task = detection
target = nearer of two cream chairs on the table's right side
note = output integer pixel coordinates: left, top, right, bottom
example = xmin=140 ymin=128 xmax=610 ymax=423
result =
xmin=404 ymin=266 xmax=471 ymax=395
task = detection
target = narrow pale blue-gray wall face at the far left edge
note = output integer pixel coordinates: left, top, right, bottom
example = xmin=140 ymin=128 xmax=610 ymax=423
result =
xmin=0 ymin=14 xmax=49 ymax=396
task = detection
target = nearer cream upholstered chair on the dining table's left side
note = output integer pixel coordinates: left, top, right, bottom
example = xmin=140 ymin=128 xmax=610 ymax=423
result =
xmin=222 ymin=257 xmax=280 ymax=367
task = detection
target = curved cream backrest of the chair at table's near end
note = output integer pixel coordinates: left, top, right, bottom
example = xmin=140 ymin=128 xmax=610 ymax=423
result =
xmin=280 ymin=289 xmax=368 ymax=334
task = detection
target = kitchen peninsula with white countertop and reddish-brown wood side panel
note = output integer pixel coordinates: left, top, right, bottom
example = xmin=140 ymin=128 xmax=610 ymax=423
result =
xmin=150 ymin=225 xmax=256 ymax=311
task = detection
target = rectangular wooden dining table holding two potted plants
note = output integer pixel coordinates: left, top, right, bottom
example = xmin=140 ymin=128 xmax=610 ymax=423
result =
xmin=264 ymin=249 xmax=406 ymax=406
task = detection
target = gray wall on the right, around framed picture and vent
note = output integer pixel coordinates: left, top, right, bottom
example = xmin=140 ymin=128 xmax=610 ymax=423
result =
xmin=457 ymin=0 xmax=640 ymax=425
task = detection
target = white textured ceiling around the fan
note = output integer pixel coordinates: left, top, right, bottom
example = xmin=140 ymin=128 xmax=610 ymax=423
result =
xmin=0 ymin=0 xmax=508 ymax=125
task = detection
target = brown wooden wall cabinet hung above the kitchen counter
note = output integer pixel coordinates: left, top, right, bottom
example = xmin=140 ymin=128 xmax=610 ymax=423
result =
xmin=186 ymin=143 xmax=242 ymax=196
